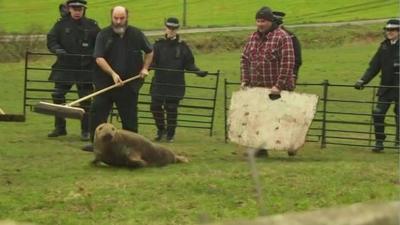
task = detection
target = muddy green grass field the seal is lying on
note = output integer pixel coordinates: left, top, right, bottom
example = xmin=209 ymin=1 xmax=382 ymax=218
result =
xmin=0 ymin=23 xmax=400 ymax=224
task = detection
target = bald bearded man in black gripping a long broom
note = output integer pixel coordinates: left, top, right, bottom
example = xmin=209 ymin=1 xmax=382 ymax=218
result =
xmin=82 ymin=6 xmax=153 ymax=151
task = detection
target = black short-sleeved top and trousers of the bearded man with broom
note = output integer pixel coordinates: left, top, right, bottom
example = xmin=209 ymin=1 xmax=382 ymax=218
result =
xmin=90 ymin=26 xmax=152 ymax=140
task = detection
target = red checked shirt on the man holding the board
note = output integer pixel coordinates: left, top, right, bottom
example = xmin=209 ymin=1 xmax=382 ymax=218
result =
xmin=240 ymin=28 xmax=294 ymax=90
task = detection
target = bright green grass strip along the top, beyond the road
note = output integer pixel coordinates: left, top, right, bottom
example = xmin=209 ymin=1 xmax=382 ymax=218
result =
xmin=0 ymin=0 xmax=399 ymax=33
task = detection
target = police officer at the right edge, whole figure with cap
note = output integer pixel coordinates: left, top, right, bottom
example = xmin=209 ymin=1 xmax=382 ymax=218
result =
xmin=354 ymin=19 xmax=400 ymax=152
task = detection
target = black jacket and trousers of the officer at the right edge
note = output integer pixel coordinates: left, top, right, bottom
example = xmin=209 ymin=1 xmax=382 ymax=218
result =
xmin=361 ymin=39 xmax=400 ymax=141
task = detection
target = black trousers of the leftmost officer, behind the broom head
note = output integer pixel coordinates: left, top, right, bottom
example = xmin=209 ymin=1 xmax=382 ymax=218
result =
xmin=51 ymin=82 xmax=93 ymax=132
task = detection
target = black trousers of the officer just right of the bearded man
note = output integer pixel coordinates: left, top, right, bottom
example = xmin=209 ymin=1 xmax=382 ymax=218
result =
xmin=150 ymin=96 xmax=180 ymax=137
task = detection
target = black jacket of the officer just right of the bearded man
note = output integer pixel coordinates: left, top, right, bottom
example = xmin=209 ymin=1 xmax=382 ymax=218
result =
xmin=150 ymin=36 xmax=199 ymax=99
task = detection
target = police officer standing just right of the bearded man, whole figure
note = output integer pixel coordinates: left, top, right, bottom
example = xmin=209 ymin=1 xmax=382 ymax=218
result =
xmin=150 ymin=17 xmax=207 ymax=142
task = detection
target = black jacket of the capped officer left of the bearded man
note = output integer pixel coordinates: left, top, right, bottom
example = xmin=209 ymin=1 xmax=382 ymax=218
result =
xmin=47 ymin=16 xmax=100 ymax=81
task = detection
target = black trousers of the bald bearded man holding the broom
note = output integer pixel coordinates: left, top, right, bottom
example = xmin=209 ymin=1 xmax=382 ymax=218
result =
xmin=90 ymin=86 xmax=139 ymax=141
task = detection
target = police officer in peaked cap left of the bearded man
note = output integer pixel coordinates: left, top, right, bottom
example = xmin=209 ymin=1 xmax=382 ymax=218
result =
xmin=47 ymin=0 xmax=100 ymax=140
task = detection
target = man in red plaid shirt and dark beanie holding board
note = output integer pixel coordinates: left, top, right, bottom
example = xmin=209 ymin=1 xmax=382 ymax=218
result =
xmin=240 ymin=7 xmax=295 ymax=157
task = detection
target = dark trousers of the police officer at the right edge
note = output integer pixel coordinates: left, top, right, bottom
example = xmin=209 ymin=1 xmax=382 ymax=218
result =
xmin=372 ymin=95 xmax=399 ymax=141
